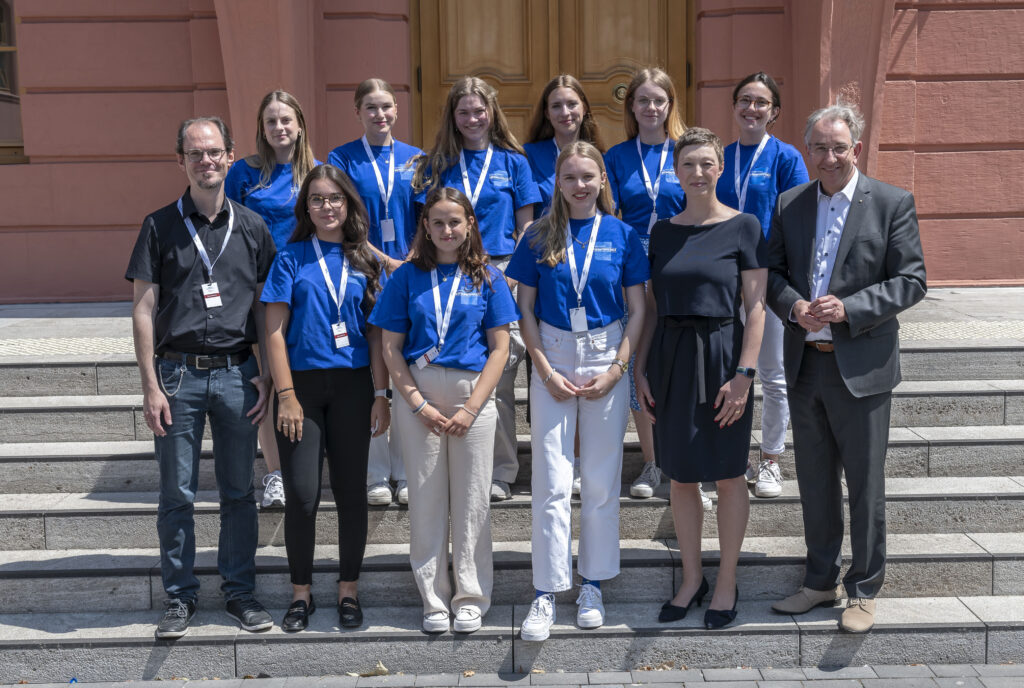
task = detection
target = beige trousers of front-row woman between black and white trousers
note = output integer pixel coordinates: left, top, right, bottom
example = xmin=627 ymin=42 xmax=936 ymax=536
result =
xmin=393 ymin=366 xmax=497 ymax=614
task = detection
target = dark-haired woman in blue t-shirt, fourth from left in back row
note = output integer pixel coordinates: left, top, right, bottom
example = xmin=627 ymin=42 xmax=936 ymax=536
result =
xmin=522 ymin=74 xmax=604 ymax=217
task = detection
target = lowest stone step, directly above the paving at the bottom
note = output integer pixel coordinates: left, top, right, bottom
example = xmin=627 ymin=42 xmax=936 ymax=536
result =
xmin=0 ymin=597 xmax=1024 ymax=685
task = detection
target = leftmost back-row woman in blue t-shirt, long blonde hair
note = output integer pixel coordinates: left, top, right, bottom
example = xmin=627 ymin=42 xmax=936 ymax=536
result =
xmin=224 ymin=91 xmax=318 ymax=509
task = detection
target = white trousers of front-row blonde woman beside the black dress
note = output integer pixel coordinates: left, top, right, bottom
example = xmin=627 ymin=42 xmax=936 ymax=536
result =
xmin=530 ymin=321 xmax=630 ymax=593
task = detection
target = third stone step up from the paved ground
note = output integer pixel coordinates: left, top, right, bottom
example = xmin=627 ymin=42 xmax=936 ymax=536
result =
xmin=0 ymin=477 xmax=1024 ymax=550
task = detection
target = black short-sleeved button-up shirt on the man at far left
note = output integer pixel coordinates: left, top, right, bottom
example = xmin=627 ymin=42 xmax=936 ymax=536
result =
xmin=125 ymin=190 xmax=275 ymax=354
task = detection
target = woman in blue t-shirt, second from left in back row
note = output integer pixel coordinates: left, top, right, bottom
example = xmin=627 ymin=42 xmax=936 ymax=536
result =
xmin=327 ymin=79 xmax=423 ymax=507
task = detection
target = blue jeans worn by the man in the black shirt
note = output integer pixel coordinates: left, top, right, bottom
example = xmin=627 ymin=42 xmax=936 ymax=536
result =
xmin=156 ymin=356 xmax=259 ymax=600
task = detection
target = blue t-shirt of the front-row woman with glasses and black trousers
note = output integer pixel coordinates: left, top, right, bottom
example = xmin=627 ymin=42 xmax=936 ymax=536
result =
xmin=260 ymin=239 xmax=370 ymax=371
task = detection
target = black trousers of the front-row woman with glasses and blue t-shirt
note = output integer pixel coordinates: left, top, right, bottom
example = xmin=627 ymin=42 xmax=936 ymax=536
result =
xmin=274 ymin=367 xmax=374 ymax=586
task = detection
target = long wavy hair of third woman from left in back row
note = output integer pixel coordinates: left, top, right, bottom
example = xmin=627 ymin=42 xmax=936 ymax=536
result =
xmin=413 ymin=77 xmax=526 ymax=190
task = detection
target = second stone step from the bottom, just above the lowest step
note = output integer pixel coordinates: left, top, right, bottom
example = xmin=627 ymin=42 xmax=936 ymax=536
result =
xmin=0 ymin=532 xmax=1024 ymax=613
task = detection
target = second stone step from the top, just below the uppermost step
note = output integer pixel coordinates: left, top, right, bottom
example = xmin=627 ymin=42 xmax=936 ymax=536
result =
xmin=0 ymin=380 xmax=1024 ymax=442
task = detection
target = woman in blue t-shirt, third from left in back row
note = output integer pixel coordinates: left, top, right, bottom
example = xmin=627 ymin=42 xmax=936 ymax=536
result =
xmin=413 ymin=77 xmax=541 ymax=502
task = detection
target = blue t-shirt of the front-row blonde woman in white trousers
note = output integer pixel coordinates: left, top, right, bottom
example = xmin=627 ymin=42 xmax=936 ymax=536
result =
xmin=505 ymin=215 xmax=650 ymax=332
